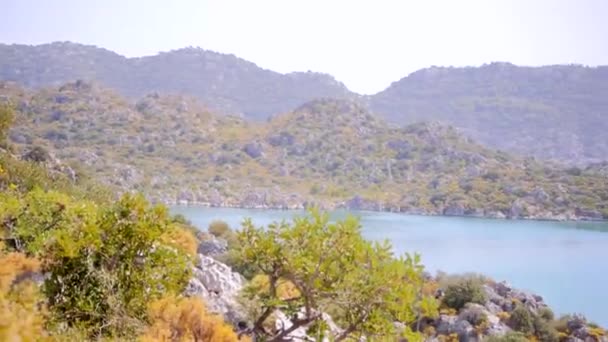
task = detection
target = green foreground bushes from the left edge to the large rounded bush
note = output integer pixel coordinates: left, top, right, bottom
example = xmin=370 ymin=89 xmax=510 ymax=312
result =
xmin=0 ymin=189 xmax=190 ymax=336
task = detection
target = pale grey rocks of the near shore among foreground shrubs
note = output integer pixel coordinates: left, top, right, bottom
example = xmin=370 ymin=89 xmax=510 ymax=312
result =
xmin=186 ymin=239 xmax=608 ymax=342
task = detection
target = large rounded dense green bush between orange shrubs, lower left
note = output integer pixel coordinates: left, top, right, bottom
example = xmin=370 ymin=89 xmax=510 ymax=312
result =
xmin=45 ymin=195 xmax=189 ymax=335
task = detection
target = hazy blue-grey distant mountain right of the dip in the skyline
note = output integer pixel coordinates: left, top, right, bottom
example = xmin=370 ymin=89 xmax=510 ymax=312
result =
xmin=369 ymin=63 xmax=608 ymax=163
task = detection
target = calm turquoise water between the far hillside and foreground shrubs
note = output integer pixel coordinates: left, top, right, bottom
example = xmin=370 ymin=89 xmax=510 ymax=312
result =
xmin=172 ymin=206 xmax=608 ymax=326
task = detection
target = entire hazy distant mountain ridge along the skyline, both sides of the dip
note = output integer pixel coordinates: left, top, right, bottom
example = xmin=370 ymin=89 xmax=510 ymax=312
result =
xmin=0 ymin=42 xmax=608 ymax=164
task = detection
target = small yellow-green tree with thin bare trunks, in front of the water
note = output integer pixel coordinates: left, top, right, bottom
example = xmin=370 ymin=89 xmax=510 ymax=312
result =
xmin=239 ymin=210 xmax=423 ymax=341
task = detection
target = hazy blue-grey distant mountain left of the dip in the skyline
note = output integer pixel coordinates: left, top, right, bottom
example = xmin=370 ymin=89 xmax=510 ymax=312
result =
xmin=0 ymin=42 xmax=356 ymax=120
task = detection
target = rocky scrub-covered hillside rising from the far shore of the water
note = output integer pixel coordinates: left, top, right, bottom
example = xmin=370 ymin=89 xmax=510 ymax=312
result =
xmin=0 ymin=82 xmax=608 ymax=219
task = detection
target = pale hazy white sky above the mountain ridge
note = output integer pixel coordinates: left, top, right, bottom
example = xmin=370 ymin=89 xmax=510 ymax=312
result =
xmin=0 ymin=0 xmax=608 ymax=93
